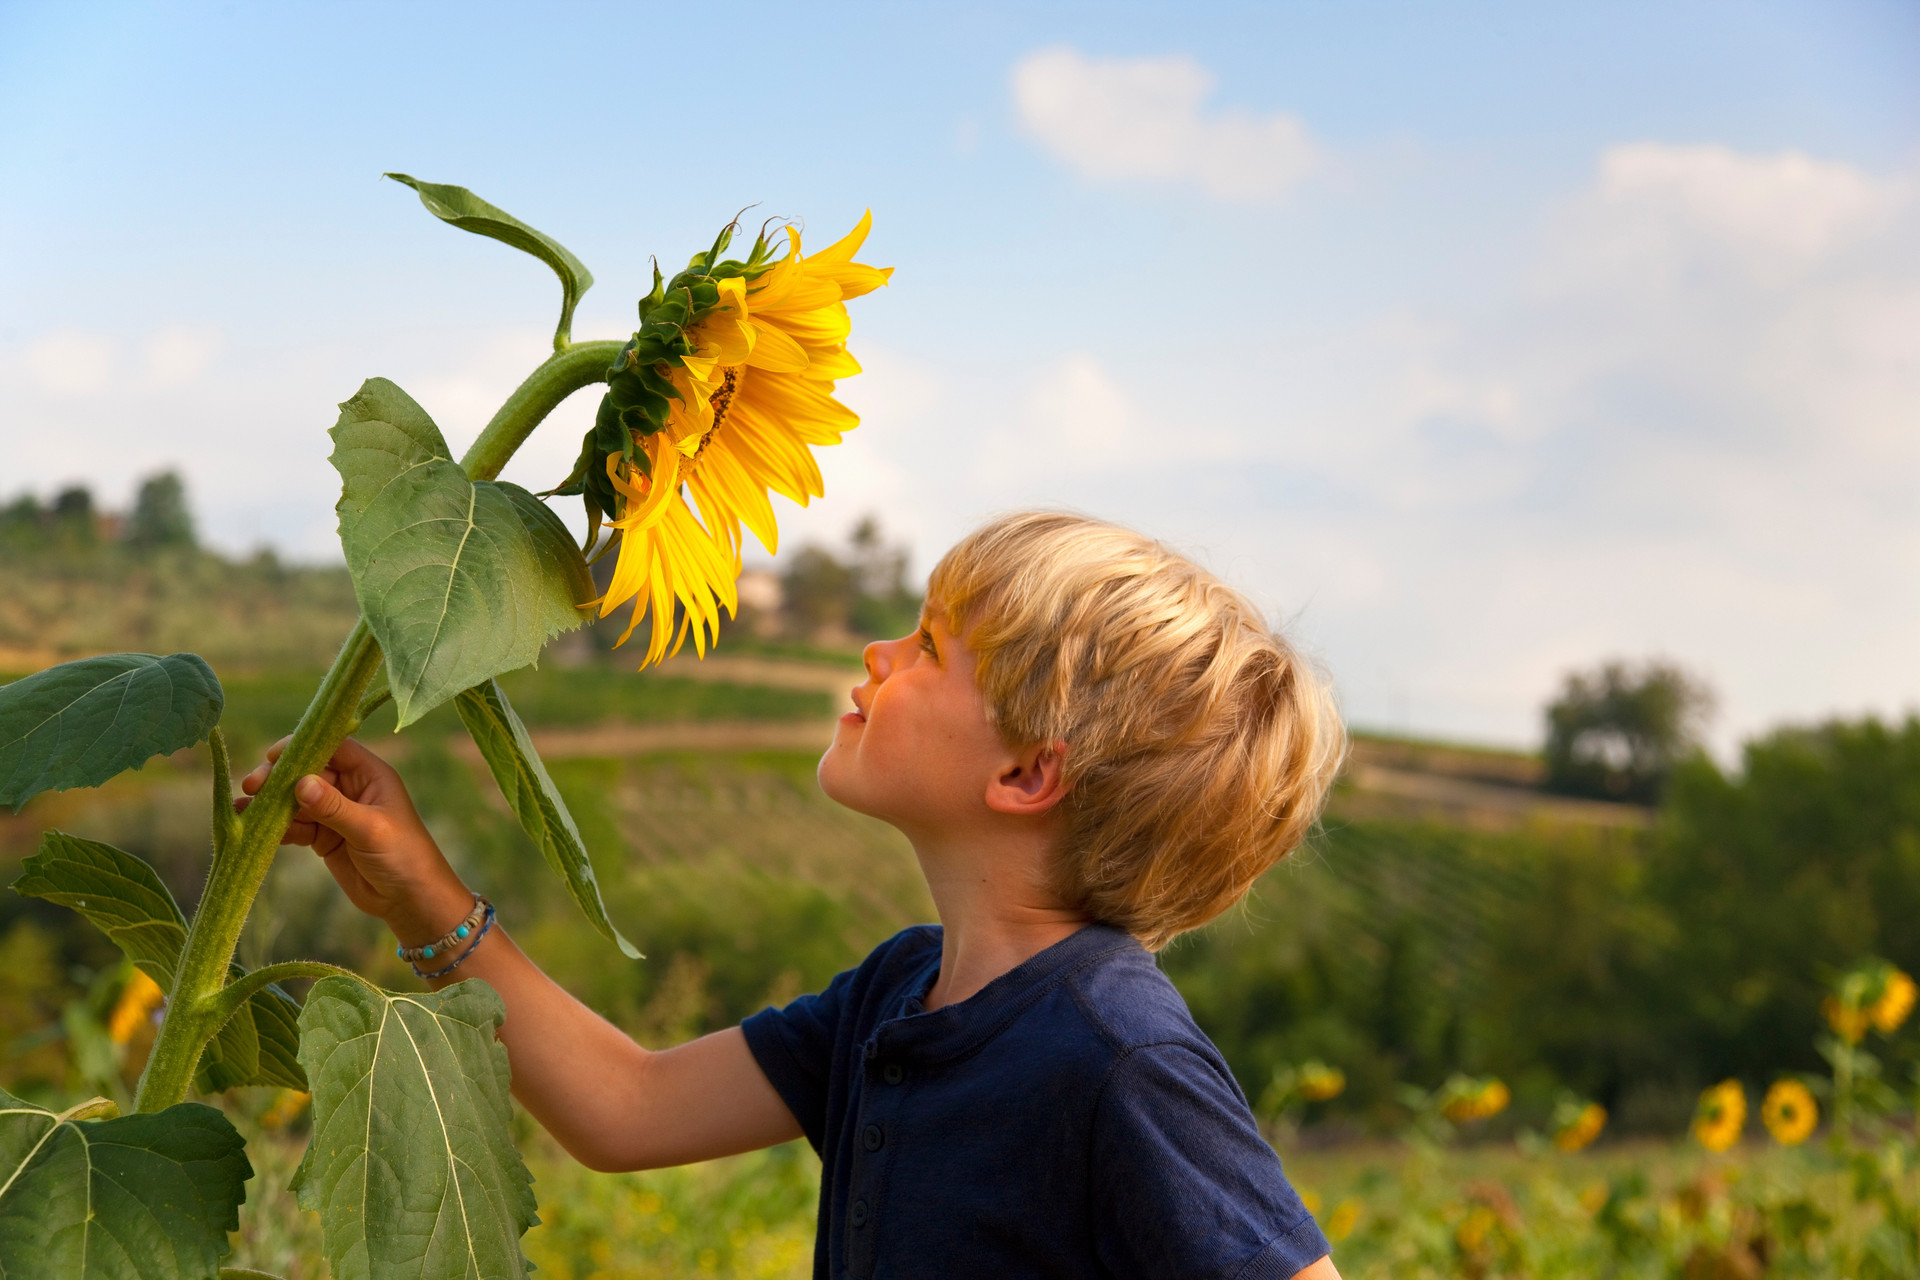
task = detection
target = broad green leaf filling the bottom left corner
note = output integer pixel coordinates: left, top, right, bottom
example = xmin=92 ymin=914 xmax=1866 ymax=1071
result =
xmin=0 ymin=1090 xmax=253 ymax=1280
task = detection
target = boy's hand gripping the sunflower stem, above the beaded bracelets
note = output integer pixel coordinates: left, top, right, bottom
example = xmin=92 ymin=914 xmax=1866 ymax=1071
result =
xmin=234 ymin=739 xmax=474 ymax=946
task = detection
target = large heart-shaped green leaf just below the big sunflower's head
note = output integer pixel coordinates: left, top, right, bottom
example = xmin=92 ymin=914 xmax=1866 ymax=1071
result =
xmin=330 ymin=378 xmax=597 ymax=727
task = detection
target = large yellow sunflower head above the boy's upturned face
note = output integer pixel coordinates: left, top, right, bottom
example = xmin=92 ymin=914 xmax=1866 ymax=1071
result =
xmin=583 ymin=213 xmax=893 ymax=666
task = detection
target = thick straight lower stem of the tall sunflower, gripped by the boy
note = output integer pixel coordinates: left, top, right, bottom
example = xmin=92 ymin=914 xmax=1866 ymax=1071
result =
xmin=134 ymin=618 xmax=380 ymax=1111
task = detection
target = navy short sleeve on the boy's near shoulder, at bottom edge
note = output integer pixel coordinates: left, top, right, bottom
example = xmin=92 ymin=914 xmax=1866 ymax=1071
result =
xmin=1092 ymin=1044 xmax=1331 ymax=1280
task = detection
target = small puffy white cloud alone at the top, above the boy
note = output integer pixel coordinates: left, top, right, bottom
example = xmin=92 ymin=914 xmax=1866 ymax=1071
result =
xmin=1014 ymin=48 xmax=1319 ymax=201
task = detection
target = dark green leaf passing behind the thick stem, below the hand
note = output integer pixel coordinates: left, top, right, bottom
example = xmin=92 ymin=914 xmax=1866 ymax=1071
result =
xmin=13 ymin=831 xmax=307 ymax=1092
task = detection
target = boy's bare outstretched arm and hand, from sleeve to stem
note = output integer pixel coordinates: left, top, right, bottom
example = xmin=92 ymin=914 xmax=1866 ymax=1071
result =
xmin=240 ymin=741 xmax=801 ymax=1171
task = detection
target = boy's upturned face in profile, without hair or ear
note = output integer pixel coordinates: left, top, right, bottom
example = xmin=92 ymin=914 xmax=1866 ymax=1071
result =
xmin=820 ymin=603 xmax=1014 ymax=837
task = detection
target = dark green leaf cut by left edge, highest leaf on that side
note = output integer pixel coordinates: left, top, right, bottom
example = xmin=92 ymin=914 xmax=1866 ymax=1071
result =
xmin=0 ymin=652 xmax=227 ymax=814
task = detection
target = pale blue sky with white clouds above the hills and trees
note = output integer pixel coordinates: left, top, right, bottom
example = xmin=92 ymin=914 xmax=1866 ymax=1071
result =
xmin=0 ymin=0 xmax=1920 ymax=745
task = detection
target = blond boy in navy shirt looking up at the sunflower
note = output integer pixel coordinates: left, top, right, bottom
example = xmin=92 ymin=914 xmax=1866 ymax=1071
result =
xmin=242 ymin=512 xmax=1344 ymax=1280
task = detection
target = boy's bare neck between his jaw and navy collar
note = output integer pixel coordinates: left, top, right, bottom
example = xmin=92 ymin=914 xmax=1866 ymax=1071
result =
xmin=914 ymin=839 xmax=1089 ymax=1013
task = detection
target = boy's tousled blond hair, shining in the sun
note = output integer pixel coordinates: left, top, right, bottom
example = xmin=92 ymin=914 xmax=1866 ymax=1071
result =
xmin=927 ymin=512 xmax=1346 ymax=950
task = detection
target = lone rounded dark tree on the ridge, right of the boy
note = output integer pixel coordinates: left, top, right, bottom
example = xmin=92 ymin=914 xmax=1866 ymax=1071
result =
xmin=1546 ymin=660 xmax=1713 ymax=804
